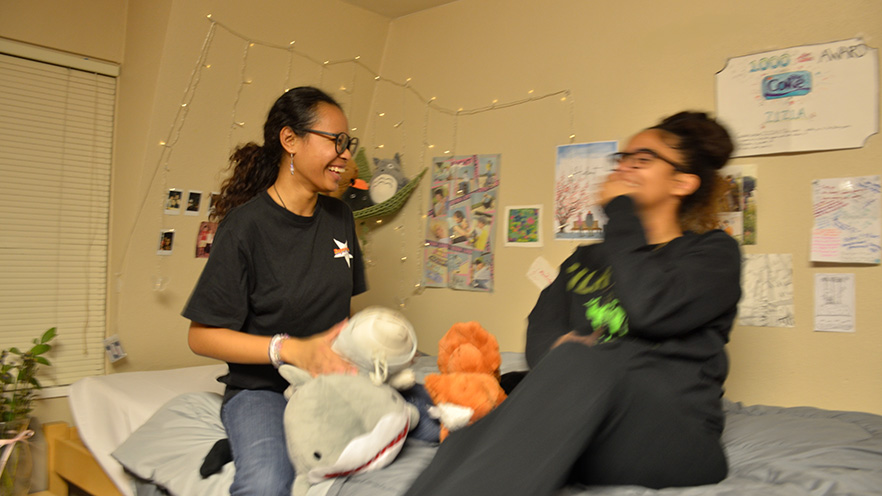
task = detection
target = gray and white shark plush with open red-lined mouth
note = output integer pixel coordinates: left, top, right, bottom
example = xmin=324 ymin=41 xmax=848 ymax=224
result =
xmin=279 ymin=365 xmax=419 ymax=496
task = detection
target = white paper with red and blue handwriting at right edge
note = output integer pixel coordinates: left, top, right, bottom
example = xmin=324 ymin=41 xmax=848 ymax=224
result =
xmin=812 ymin=176 xmax=882 ymax=264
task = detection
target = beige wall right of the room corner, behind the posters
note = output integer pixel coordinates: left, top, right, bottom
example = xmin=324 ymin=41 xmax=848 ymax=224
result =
xmin=352 ymin=0 xmax=882 ymax=413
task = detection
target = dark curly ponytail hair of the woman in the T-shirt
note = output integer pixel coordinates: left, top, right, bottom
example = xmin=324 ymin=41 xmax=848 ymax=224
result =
xmin=211 ymin=86 xmax=340 ymax=222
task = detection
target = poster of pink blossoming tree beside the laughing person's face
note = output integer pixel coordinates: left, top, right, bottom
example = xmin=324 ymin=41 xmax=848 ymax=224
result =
xmin=554 ymin=141 xmax=618 ymax=240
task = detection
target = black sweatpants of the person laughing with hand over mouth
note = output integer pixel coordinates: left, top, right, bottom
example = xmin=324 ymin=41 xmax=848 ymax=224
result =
xmin=406 ymin=343 xmax=728 ymax=496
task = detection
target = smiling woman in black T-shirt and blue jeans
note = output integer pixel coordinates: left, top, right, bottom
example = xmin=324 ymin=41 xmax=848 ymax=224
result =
xmin=183 ymin=87 xmax=366 ymax=495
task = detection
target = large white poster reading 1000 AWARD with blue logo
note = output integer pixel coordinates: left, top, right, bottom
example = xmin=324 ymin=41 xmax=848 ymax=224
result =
xmin=716 ymin=38 xmax=879 ymax=157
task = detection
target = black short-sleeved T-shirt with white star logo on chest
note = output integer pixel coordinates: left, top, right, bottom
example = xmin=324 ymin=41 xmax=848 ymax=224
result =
xmin=182 ymin=192 xmax=367 ymax=391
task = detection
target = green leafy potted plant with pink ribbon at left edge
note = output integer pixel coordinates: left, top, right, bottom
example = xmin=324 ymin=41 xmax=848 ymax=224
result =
xmin=0 ymin=327 xmax=56 ymax=495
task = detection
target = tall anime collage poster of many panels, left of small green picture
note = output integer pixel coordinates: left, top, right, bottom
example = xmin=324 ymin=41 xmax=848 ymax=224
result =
xmin=423 ymin=154 xmax=501 ymax=291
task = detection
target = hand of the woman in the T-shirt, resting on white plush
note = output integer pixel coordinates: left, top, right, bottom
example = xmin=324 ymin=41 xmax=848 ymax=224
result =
xmin=281 ymin=319 xmax=357 ymax=376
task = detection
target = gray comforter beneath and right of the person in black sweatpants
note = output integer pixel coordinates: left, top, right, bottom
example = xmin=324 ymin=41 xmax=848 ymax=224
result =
xmin=326 ymin=402 xmax=882 ymax=496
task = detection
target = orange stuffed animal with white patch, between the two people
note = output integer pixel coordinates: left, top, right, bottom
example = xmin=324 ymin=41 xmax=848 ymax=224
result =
xmin=425 ymin=322 xmax=506 ymax=441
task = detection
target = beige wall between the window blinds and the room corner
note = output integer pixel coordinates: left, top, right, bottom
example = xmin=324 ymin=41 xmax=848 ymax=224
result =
xmin=109 ymin=0 xmax=389 ymax=372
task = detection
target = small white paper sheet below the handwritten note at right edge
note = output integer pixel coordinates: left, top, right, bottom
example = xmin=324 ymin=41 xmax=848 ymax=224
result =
xmin=815 ymin=274 xmax=855 ymax=332
